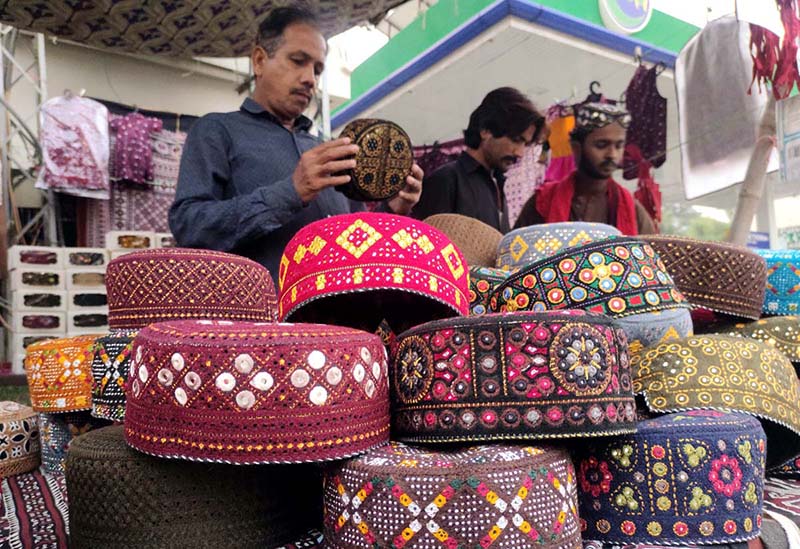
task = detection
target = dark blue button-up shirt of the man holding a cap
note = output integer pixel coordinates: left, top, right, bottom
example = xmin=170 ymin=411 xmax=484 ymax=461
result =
xmin=169 ymin=98 xmax=364 ymax=280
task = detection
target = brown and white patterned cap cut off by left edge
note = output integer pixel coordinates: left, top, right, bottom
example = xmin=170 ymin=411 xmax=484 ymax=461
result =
xmin=0 ymin=401 xmax=39 ymax=479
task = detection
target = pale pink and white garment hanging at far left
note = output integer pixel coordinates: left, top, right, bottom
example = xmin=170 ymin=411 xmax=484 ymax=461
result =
xmin=36 ymin=96 xmax=109 ymax=200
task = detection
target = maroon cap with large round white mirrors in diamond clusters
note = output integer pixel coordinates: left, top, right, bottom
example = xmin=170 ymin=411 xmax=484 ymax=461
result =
xmin=125 ymin=320 xmax=389 ymax=464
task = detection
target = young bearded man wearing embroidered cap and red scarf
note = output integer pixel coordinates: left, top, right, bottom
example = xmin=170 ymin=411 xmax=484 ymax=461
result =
xmin=514 ymin=103 xmax=657 ymax=236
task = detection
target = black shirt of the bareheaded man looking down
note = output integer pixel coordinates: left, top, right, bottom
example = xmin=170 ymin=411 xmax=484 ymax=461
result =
xmin=411 ymin=152 xmax=509 ymax=234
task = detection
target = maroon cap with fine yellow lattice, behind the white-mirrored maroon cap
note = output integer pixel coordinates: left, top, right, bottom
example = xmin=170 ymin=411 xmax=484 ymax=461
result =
xmin=106 ymin=248 xmax=277 ymax=330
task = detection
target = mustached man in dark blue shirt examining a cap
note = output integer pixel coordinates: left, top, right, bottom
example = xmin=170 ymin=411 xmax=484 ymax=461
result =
xmin=169 ymin=8 xmax=423 ymax=278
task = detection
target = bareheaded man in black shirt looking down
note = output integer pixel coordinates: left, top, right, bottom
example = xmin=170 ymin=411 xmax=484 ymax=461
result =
xmin=411 ymin=88 xmax=544 ymax=233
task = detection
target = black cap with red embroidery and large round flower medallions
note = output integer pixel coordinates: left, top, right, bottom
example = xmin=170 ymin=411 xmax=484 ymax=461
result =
xmin=391 ymin=311 xmax=634 ymax=441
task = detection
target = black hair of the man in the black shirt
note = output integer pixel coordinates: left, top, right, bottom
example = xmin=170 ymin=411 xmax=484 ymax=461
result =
xmin=464 ymin=87 xmax=544 ymax=149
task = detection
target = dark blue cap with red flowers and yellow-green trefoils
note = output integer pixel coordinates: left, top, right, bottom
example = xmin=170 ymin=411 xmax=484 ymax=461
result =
xmin=575 ymin=410 xmax=766 ymax=545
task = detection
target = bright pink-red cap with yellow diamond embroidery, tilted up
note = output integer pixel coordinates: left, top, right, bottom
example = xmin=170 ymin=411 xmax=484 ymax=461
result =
xmin=278 ymin=213 xmax=469 ymax=332
